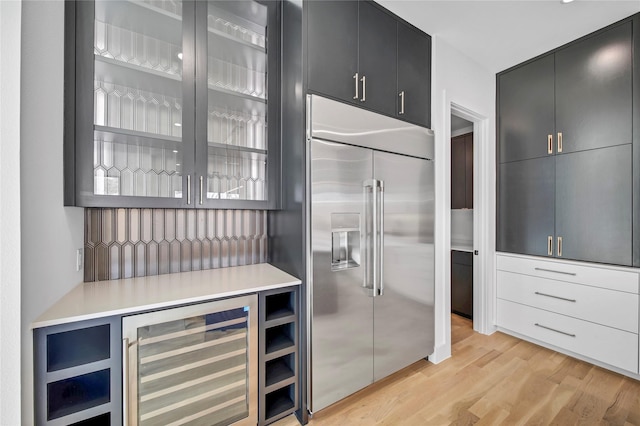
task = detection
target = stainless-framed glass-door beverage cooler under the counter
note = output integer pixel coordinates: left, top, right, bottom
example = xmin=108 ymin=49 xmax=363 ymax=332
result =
xmin=122 ymin=295 xmax=258 ymax=426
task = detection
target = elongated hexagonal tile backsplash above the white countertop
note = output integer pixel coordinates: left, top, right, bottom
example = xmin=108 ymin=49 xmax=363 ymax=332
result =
xmin=84 ymin=208 xmax=267 ymax=282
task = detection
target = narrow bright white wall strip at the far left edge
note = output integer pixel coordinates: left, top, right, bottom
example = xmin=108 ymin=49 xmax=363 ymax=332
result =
xmin=0 ymin=1 xmax=22 ymax=425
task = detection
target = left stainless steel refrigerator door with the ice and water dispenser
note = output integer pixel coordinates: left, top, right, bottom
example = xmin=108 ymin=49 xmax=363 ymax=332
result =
xmin=310 ymin=140 xmax=373 ymax=411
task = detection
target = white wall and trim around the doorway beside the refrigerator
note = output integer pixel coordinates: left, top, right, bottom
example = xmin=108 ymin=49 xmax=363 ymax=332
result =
xmin=429 ymin=34 xmax=495 ymax=362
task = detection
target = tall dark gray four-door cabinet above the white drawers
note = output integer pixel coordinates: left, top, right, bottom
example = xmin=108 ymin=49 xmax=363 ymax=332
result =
xmin=497 ymin=16 xmax=640 ymax=266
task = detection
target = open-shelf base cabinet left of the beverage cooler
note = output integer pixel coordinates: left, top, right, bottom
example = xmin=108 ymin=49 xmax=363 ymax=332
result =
xmin=33 ymin=317 xmax=122 ymax=426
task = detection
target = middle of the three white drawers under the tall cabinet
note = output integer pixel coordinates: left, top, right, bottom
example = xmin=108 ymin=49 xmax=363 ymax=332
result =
xmin=497 ymin=271 xmax=638 ymax=333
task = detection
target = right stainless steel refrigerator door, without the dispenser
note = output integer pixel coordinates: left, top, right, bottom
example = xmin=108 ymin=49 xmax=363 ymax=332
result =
xmin=373 ymin=152 xmax=435 ymax=380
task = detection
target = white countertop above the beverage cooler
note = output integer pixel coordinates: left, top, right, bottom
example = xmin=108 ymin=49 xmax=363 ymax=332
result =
xmin=31 ymin=263 xmax=301 ymax=328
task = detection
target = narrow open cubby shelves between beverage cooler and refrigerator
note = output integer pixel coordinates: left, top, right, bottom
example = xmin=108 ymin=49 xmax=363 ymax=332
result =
xmin=258 ymin=287 xmax=299 ymax=425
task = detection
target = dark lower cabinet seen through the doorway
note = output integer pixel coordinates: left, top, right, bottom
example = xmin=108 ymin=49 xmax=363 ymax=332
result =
xmin=451 ymin=250 xmax=473 ymax=319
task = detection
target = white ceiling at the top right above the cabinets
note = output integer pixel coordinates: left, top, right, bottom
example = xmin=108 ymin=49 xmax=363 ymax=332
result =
xmin=376 ymin=0 xmax=640 ymax=73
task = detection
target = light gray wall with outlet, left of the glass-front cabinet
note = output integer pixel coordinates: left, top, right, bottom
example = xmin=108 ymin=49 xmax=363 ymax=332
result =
xmin=20 ymin=0 xmax=85 ymax=425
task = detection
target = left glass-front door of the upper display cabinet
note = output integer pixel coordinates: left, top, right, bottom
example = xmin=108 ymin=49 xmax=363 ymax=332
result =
xmin=75 ymin=0 xmax=194 ymax=207
